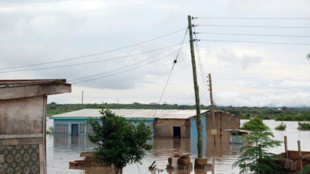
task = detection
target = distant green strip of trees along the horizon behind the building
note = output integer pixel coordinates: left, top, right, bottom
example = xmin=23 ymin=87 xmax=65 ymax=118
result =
xmin=47 ymin=102 xmax=310 ymax=121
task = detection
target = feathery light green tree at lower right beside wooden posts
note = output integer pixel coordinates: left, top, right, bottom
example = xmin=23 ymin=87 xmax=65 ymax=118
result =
xmin=233 ymin=131 xmax=281 ymax=174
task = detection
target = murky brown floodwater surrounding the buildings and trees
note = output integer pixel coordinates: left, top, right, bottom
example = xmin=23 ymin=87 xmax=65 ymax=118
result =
xmin=47 ymin=120 xmax=310 ymax=174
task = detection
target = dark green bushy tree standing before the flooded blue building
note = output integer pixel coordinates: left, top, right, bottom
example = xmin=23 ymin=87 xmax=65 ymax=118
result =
xmin=87 ymin=109 xmax=152 ymax=174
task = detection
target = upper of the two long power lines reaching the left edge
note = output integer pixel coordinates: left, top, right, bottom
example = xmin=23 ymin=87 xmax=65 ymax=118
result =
xmin=0 ymin=28 xmax=185 ymax=70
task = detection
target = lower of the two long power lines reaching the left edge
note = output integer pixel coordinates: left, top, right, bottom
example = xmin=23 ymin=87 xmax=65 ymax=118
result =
xmin=0 ymin=43 xmax=181 ymax=73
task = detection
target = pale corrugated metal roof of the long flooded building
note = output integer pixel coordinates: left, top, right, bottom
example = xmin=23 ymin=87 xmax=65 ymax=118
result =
xmin=52 ymin=109 xmax=207 ymax=119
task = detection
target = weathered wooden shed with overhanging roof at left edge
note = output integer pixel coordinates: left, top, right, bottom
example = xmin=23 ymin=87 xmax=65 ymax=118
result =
xmin=0 ymin=79 xmax=71 ymax=174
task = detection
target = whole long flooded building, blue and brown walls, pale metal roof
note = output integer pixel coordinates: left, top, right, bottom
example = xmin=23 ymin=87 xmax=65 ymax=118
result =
xmin=50 ymin=109 xmax=240 ymax=138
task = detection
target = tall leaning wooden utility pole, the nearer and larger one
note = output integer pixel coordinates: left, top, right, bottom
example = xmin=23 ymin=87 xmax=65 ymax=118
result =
xmin=188 ymin=15 xmax=203 ymax=158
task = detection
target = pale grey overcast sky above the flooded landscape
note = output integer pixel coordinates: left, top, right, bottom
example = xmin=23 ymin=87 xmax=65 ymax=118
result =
xmin=0 ymin=0 xmax=310 ymax=106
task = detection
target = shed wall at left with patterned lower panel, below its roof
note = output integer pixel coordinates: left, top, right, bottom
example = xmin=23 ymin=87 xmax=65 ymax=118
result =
xmin=0 ymin=96 xmax=47 ymax=174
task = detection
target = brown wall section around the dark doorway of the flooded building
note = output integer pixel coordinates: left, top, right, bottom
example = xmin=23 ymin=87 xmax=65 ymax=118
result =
xmin=154 ymin=118 xmax=191 ymax=138
